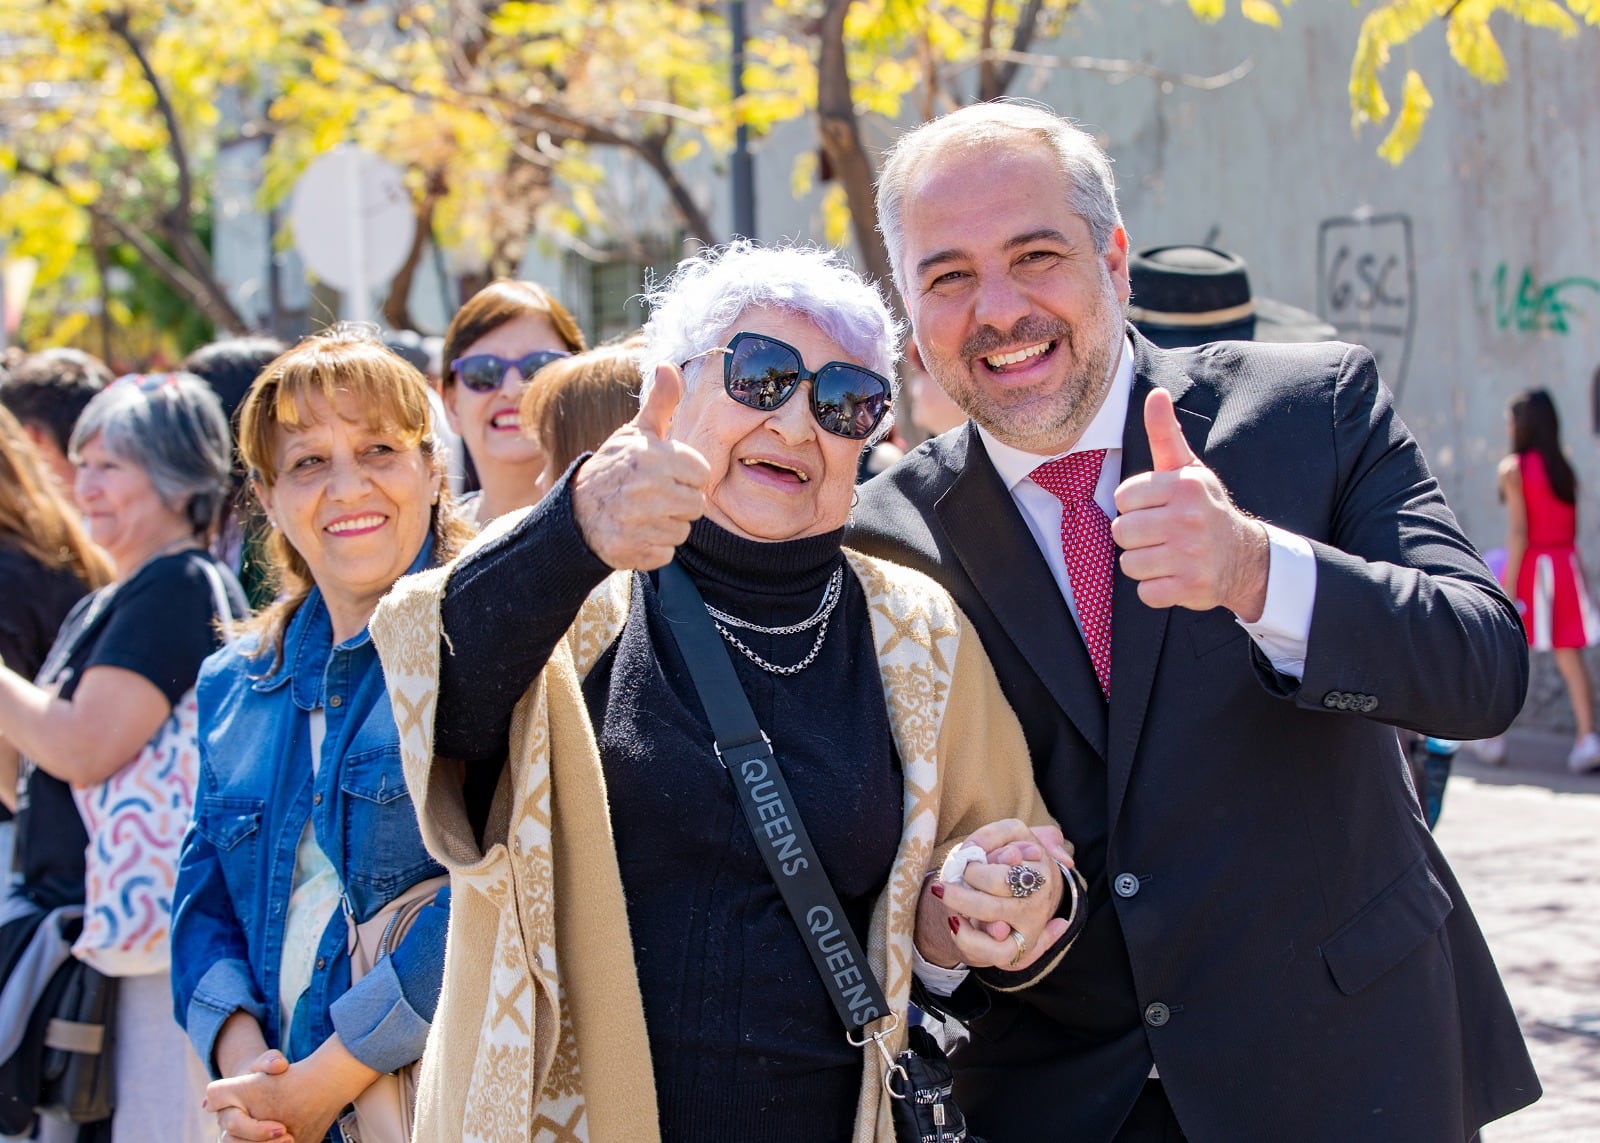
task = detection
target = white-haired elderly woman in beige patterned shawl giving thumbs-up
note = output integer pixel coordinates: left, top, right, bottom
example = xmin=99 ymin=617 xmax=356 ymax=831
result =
xmin=373 ymin=242 xmax=1067 ymax=1143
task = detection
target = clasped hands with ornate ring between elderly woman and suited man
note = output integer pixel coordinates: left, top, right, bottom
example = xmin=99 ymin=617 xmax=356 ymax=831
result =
xmin=917 ymin=818 xmax=1072 ymax=972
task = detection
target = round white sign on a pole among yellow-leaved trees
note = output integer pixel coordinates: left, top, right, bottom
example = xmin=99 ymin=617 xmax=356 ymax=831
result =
xmin=290 ymin=144 xmax=416 ymax=322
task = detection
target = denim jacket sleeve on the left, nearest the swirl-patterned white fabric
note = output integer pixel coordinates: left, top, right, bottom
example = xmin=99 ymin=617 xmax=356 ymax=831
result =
xmin=173 ymin=765 xmax=267 ymax=1076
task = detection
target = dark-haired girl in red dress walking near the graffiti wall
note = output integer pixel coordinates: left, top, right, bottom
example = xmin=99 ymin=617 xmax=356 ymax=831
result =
xmin=1499 ymin=389 xmax=1600 ymax=772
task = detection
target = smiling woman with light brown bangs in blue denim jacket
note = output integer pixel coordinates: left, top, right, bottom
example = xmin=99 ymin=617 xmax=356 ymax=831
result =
xmin=173 ymin=327 xmax=469 ymax=1143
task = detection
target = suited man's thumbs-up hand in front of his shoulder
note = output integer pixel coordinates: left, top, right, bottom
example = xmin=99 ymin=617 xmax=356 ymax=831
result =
xmin=1110 ymin=389 xmax=1270 ymax=623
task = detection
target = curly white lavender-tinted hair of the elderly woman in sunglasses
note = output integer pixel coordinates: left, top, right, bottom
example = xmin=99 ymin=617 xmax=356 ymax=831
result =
xmin=640 ymin=239 xmax=902 ymax=440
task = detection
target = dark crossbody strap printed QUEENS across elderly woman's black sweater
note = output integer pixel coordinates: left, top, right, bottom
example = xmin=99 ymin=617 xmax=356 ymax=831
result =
xmin=658 ymin=562 xmax=890 ymax=1045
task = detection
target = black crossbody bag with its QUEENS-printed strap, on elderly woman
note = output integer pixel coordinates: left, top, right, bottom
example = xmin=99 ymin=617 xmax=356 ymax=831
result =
xmin=658 ymin=562 xmax=982 ymax=1143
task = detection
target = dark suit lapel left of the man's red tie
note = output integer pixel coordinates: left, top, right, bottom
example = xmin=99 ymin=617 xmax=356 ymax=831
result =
xmin=934 ymin=424 xmax=1107 ymax=757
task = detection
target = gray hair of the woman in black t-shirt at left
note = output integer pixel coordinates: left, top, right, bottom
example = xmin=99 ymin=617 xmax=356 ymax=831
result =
xmin=67 ymin=373 xmax=232 ymax=536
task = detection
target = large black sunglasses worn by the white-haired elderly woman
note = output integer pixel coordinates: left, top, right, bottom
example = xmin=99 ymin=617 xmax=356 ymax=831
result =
xmin=683 ymin=333 xmax=891 ymax=440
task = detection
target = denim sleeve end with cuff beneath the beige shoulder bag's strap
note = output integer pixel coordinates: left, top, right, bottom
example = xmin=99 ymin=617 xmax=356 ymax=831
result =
xmin=328 ymin=885 xmax=450 ymax=1071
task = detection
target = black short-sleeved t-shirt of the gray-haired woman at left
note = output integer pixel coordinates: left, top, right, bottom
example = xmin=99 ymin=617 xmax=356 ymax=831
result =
xmin=13 ymin=551 xmax=245 ymax=909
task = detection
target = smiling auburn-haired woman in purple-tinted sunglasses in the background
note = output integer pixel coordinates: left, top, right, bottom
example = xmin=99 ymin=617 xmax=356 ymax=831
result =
xmin=442 ymin=279 xmax=584 ymax=525
